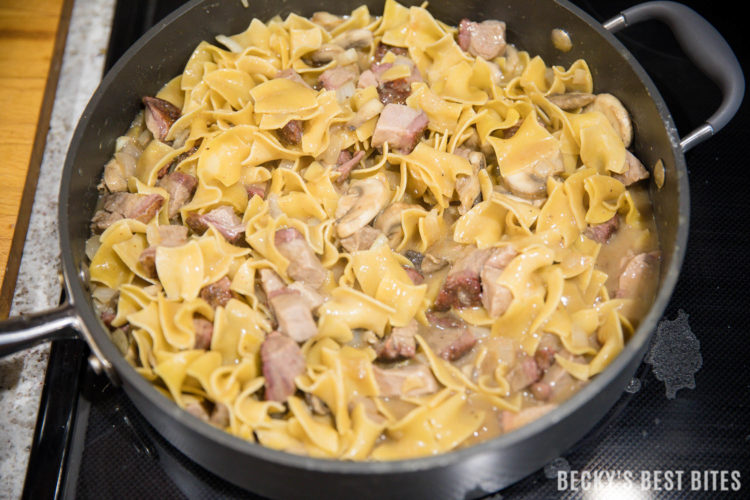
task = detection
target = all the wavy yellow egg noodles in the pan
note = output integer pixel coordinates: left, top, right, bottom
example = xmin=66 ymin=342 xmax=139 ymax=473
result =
xmin=89 ymin=0 xmax=657 ymax=460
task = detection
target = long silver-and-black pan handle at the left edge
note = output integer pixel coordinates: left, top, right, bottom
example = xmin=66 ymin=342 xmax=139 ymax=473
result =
xmin=0 ymin=304 xmax=78 ymax=357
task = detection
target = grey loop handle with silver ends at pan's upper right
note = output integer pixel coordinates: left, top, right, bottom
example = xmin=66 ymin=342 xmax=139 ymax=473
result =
xmin=603 ymin=2 xmax=745 ymax=153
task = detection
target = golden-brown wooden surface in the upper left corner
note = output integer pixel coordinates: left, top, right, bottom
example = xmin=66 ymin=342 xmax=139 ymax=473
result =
xmin=0 ymin=0 xmax=73 ymax=318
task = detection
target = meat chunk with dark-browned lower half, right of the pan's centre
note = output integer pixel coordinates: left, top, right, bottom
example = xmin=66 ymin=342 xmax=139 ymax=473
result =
xmin=432 ymin=248 xmax=493 ymax=311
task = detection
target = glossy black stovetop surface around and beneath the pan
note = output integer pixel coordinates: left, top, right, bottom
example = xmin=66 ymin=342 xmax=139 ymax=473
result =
xmin=24 ymin=0 xmax=750 ymax=499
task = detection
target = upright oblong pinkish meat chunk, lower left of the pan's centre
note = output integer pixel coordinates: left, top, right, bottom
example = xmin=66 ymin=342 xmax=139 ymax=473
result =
xmin=260 ymin=332 xmax=305 ymax=402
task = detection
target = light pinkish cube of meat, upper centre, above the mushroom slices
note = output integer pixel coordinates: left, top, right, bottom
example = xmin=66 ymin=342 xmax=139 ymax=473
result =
xmin=372 ymin=104 xmax=429 ymax=154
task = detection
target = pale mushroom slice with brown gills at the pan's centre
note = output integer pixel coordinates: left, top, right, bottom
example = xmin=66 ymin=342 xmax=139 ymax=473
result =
xmin=335 ymin=175 xmax=390 ymax=238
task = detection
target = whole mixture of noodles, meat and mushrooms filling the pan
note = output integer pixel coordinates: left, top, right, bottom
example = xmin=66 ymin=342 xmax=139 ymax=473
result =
xmin=87 ymin=0 xmax=659 ymax=460
